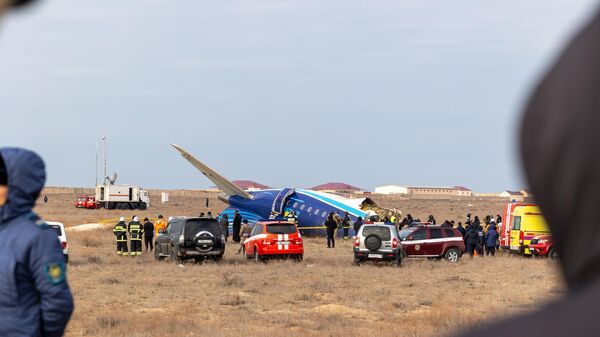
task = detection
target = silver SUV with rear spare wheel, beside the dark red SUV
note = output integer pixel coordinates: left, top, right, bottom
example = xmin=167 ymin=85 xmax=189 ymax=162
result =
xmin=354 ymin=224 xmax=402 ymax=267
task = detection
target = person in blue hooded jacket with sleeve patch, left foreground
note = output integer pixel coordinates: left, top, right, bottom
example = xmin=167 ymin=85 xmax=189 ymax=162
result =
xmin=0 ymin=148 xmax=73 ymax=337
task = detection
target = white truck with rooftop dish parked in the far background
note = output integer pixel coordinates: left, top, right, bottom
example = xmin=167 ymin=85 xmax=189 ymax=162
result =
xmin=96 ymin=185 xmax=150 ymax=210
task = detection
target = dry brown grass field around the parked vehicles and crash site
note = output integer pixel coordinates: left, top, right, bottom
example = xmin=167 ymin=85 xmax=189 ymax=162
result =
xmin=32 ymin=192 xmax=564 ymax=337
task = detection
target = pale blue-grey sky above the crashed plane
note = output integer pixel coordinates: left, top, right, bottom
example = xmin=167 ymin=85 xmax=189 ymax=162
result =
xmin=0 ymin=0 xmax=598 ymax=192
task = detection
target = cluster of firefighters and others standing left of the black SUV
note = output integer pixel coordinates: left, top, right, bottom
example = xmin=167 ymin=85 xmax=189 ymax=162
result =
xmin=113 ymin=215 xmax=167 ymax=256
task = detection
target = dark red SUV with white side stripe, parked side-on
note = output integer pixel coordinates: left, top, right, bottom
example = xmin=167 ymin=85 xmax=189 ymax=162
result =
xmin=400 ymin=226 xmax=465 ymax=262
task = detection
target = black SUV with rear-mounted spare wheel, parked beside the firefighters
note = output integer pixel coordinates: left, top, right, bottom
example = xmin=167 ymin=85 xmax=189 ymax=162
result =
xmin=154 ymin=217 xmax=225 ymax=261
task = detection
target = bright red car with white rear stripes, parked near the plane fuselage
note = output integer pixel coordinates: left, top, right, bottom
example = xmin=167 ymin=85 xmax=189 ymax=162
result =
xmin=244 ymin=221 xmax=304 ymax=261
